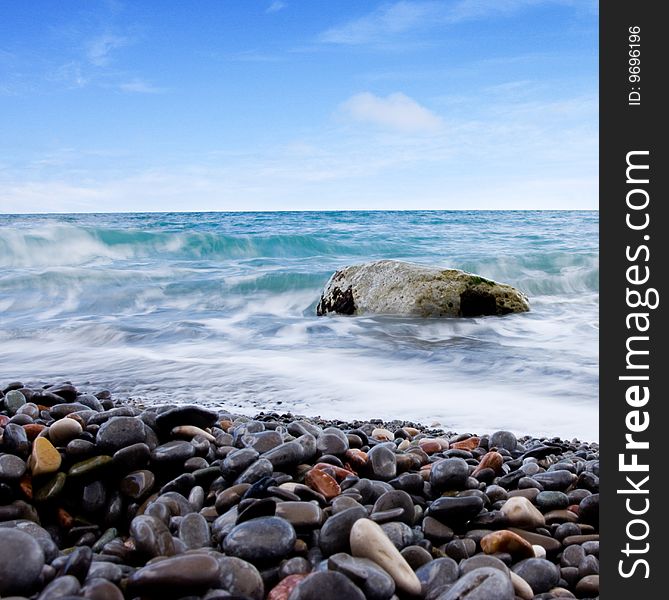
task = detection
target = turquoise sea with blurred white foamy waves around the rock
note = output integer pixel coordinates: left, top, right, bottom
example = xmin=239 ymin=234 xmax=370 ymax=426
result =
xmin=0 ymin=211 xmax=599 ymax=441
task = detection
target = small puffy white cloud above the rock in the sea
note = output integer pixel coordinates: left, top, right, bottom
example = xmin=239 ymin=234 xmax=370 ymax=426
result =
xmin=340 ymin=92 xmax=443 ymax=133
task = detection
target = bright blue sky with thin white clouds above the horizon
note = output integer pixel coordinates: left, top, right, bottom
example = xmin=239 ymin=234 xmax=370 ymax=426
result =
xmin=0 ymin=0 xmax=598 ymax=213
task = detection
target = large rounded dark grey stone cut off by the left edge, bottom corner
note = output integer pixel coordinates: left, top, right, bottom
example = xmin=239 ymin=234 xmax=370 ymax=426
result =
xmin=0 ymin=528 xmax=44 ymax=596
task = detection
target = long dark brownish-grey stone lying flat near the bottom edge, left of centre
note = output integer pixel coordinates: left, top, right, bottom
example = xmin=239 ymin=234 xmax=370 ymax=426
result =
xmin=128 ymin=554 xmax=219 ymax=596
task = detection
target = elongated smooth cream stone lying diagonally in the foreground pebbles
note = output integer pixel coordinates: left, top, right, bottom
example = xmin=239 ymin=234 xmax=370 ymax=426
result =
xmin=350 ymin=519 xmax=421 ymax=595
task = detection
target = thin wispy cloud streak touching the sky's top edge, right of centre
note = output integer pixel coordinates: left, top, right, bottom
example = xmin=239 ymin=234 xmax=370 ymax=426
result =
xmin=318 ymin=0 xmax=589 ymax=45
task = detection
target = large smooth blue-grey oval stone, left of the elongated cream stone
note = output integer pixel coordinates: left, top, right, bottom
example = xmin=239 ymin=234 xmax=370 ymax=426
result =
xmin=223 ymin=517 xmax=296 ymax=563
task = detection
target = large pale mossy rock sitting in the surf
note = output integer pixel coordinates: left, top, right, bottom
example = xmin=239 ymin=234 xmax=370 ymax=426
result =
xmin=316 ymin=260 xmax=530 ymax=317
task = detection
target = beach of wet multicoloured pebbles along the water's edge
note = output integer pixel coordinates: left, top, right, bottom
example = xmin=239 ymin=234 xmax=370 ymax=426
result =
xmin=0 ymin=383 xmax=599 ymax=600
